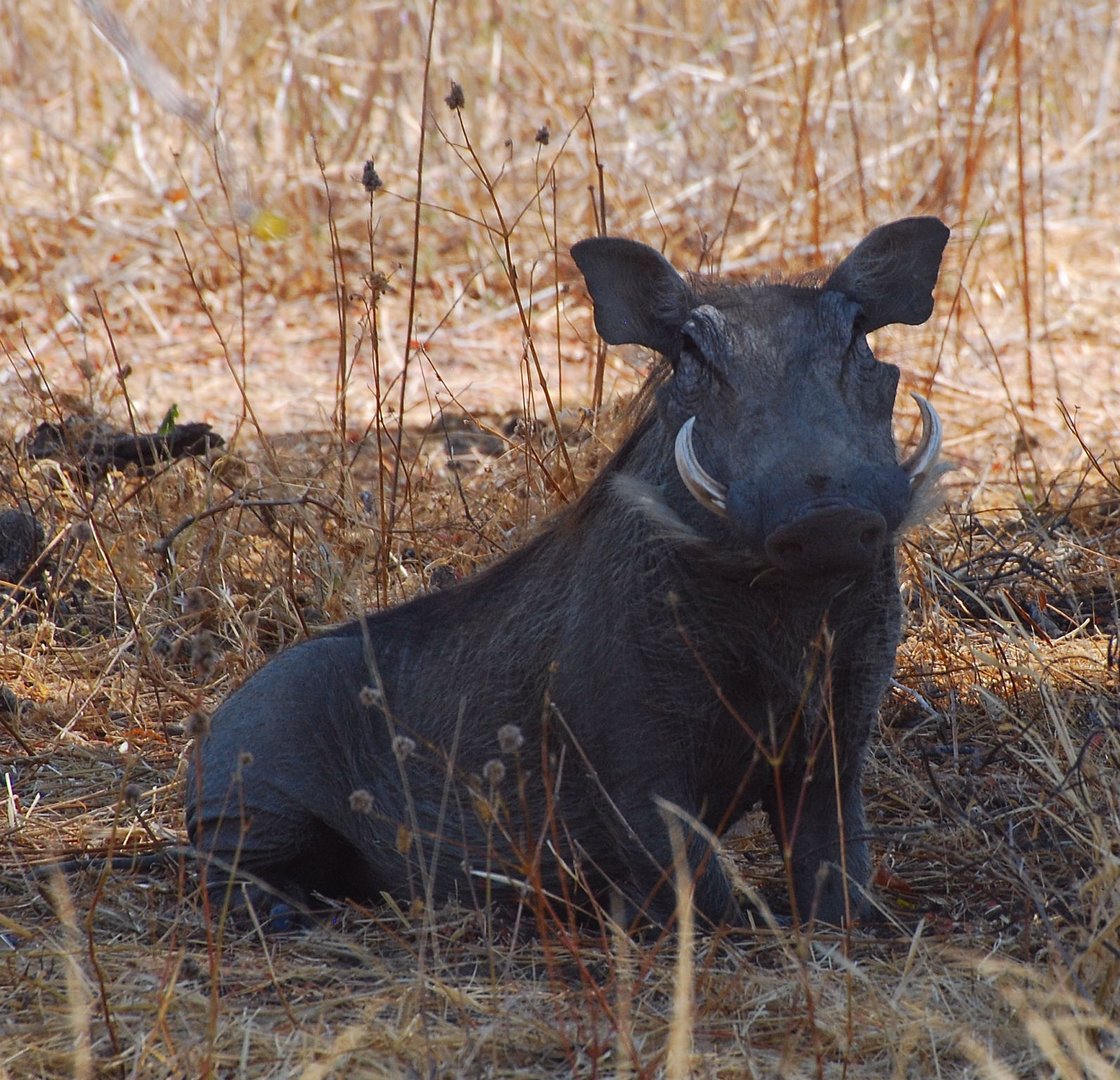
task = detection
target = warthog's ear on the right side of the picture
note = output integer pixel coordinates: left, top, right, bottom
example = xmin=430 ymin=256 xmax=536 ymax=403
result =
xmin=824 ymin=217 xmax=949 ymax=334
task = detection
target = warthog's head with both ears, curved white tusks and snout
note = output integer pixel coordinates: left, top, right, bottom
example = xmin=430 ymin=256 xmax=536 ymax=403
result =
xmin=572 ymin=217 xmax=949 ymax=578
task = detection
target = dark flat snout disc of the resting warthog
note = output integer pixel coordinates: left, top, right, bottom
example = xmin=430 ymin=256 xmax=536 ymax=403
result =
xmin=765 ymin=505 xmax=887 ymax=577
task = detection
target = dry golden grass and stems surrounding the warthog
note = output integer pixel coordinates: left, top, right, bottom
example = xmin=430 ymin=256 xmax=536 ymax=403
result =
xmin=0 ymin=0 xmax=1120 ymax=1080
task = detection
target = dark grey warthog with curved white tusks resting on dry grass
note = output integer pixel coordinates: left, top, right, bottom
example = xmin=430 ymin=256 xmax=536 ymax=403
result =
xmin=186 ymin=217 xmax=949 ymax=924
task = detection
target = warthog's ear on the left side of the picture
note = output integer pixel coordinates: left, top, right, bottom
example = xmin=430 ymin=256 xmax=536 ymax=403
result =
xmin=571 ymin=236 xmax=691 ymax=354
